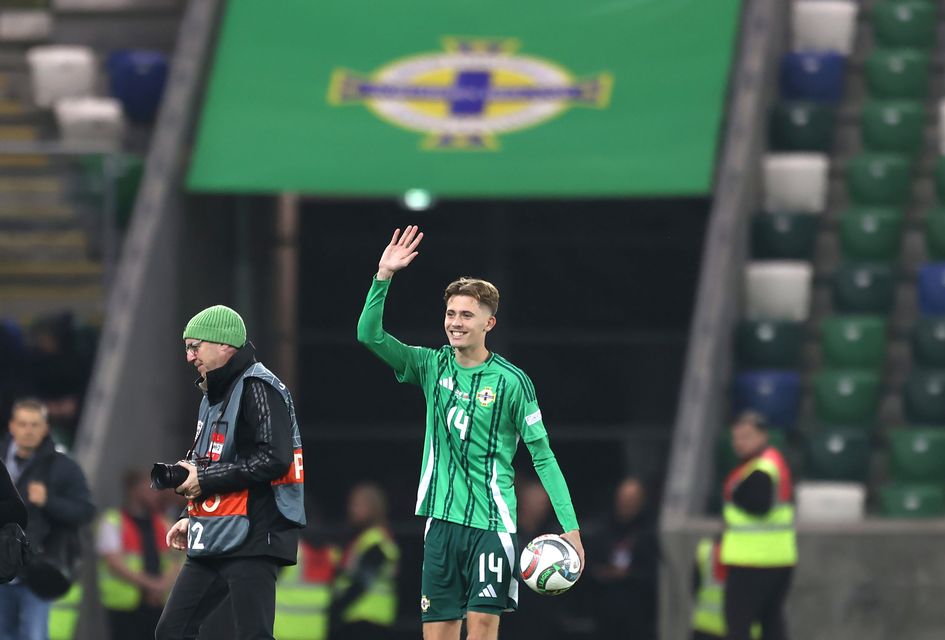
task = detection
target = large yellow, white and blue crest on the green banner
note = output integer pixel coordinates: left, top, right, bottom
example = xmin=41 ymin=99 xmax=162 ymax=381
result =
xmin=328 ymin=37 xmax=613 ymax=150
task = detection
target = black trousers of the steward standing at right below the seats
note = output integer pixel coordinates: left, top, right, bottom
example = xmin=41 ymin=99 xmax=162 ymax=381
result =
xmin=725 ymin=567 xmax=794 ymax=640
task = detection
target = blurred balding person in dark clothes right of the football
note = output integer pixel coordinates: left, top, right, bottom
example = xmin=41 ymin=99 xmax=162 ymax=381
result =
xmin=589 ymin=477 xmax=659 ymax=640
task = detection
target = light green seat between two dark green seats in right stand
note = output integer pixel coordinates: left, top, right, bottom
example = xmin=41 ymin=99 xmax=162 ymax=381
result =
xmin=820 ymin=316 xmax=886 ymax=369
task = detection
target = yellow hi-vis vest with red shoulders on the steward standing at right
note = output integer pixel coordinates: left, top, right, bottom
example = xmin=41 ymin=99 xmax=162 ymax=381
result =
xmin=721 ymin=447 xmax=797 ymax=568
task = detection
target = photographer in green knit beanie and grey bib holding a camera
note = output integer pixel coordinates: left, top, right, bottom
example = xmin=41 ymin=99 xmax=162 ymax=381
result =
xmin=152 ymin=305 xmax=305 ymax=640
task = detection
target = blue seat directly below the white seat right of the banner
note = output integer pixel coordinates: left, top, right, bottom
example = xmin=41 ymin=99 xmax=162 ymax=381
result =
xmin=781 ymin=51 xmax=846 ymax=102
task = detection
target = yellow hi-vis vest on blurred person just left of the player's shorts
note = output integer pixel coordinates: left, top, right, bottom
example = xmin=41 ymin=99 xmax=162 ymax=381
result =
xmin=335 ymin=527 xmax=400 ymax=627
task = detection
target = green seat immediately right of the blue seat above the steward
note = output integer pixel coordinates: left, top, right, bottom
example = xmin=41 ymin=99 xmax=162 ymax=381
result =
xmin=814 ymin=369 xmax=880 ymax=427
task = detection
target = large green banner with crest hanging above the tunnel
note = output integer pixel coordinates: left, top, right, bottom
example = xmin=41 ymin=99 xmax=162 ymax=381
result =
xmin=188 ymin=0 xmax=741 ymax=197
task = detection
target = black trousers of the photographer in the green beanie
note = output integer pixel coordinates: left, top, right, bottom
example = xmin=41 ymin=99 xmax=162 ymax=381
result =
xmin=154 ymin=557 xmax=278 ymax=640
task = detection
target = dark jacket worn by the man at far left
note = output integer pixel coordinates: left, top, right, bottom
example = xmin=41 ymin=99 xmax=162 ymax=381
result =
xmin=2 ymin=435 xmax=95 ymax=548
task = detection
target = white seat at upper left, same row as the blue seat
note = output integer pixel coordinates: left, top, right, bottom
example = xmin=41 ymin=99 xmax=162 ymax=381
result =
xmin=26 ymin=45 xmax=95 ymax=108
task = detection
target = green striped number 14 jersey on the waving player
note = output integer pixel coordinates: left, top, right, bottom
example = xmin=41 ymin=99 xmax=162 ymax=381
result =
xmin=359 ymin=281 xmax=546 ymax=533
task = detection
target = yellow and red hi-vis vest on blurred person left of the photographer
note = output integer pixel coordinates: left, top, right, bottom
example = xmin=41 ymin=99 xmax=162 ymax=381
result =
xmin=98 ymin=509 xmax=168 ymax=611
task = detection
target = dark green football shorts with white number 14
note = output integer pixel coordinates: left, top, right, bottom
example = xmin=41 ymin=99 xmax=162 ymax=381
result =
xmin=420 ymin=518 xmax=518 ymax=622
